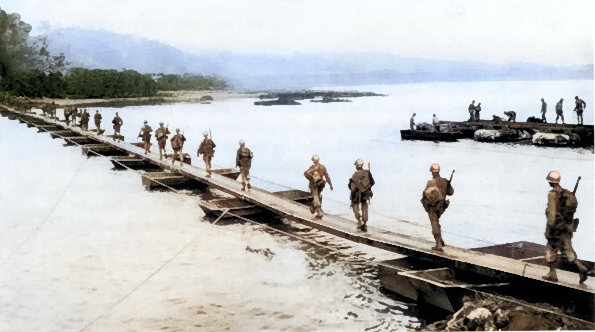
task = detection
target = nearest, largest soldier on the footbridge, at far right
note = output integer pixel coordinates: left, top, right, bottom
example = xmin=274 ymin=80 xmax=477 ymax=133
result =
xmin=543 ymin=171 xmax=593 ymax=284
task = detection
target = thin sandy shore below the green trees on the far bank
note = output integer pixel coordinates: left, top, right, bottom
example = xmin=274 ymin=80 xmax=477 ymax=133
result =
xmin=33 ymin=90 xmax=259 ymax=106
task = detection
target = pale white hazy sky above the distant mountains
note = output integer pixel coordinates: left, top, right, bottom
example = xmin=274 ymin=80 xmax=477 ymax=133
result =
xmin=1 ymin=0 xmax=595 ymax=65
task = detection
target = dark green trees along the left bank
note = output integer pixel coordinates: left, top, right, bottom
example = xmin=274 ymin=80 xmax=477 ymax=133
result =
xmin=0 ymin=9 xmax=228 ymax=98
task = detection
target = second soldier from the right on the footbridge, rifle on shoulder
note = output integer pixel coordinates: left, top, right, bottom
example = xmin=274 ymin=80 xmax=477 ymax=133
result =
xmin=421 ymin=164 xmax=454 ymax=251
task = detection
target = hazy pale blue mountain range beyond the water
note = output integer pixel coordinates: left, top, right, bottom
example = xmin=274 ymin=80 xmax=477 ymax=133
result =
xmin=48 ymin=28 xmax=593 ymax=90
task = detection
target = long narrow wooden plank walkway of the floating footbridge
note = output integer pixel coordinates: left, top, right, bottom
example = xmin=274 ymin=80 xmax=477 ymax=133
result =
xmin=5 ymin=107 xmax=595 ymax=295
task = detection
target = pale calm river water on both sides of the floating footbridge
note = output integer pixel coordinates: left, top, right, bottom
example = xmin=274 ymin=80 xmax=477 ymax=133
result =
xmin=0 ymin=81 xmax=595 ymax=331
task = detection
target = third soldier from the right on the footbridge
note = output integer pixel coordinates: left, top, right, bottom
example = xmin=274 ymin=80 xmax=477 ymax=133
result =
xmin=347 ymin=159 xmax=374 ymax=232
